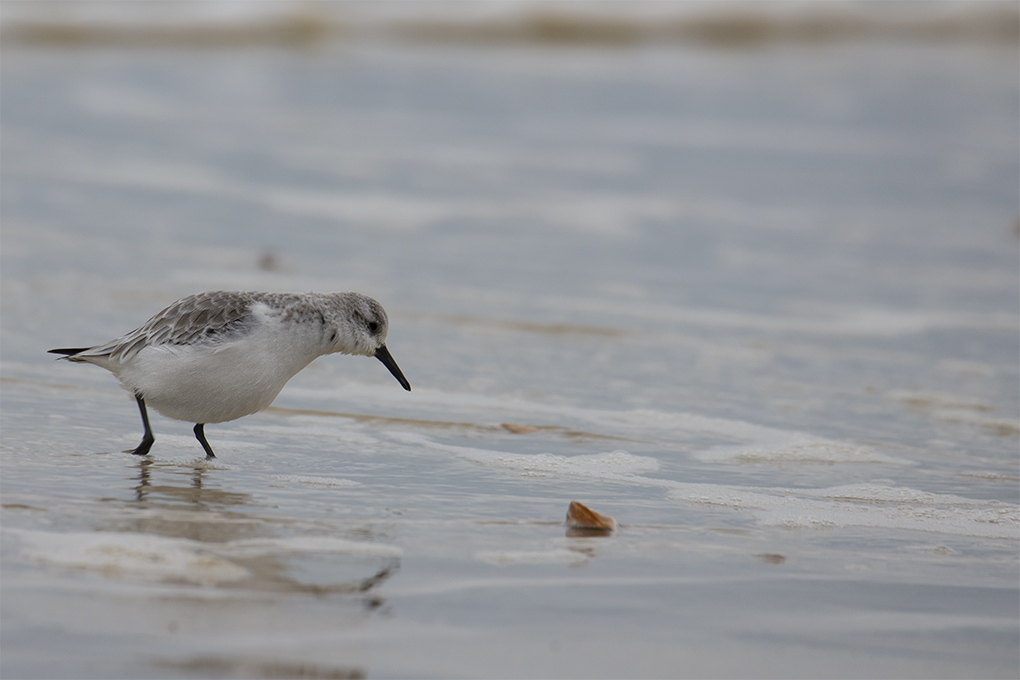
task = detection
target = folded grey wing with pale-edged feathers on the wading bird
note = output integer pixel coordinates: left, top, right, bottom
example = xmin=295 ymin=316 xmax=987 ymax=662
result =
xmin=67 ymin=291 xmax=258 ymax=361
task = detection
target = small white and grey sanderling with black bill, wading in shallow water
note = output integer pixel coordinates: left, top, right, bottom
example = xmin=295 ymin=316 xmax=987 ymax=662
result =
xmin=50 ymin=291 xmax=411 ymax=458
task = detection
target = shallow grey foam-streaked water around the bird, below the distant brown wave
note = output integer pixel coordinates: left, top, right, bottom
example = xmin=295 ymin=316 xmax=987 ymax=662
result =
xmin=0 ymin=31 xmax=1020 ymax=678
